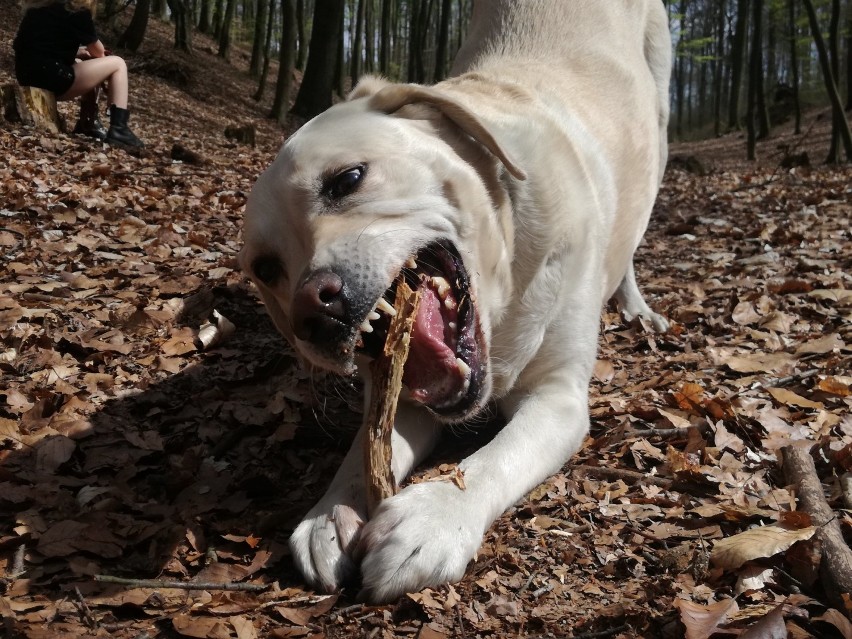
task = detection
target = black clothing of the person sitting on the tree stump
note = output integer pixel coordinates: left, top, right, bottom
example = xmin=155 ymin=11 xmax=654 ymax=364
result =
xmin=12 ymin=0 xmax=98 ymax=95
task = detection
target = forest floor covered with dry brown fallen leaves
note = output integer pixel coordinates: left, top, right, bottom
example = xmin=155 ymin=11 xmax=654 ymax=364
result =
xmin=0 ymin=10 xmax=852 ymax=639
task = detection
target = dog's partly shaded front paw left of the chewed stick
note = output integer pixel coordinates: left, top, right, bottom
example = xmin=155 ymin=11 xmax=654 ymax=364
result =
xmin=290 ymin=502 xmax=365 ymax=593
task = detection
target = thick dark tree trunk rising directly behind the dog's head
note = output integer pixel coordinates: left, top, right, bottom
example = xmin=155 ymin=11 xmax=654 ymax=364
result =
xmin=293 ymin=0 xmax=344 ymax=119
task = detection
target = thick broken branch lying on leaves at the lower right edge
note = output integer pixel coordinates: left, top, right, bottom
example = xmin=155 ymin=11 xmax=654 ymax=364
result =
xmin=781 ymin=446 xmax=852 ymax=610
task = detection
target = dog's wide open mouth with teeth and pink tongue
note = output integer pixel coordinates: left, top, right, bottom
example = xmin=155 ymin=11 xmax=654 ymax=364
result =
xmin=358 ymin=242 xmax=484 ymax=419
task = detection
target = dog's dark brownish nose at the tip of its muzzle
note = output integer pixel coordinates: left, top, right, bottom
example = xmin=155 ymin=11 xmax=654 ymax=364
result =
xmin=290 ymin=271 xmax=349 ymax=343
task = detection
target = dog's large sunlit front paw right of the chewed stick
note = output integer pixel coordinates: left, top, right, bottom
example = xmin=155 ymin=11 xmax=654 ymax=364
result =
xmin=358 ymin=482 xmax=482 ymax=602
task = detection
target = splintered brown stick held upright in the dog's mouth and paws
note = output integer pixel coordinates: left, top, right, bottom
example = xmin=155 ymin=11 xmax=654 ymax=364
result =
xmin=364 ymin=278 xmax=420 ymax=516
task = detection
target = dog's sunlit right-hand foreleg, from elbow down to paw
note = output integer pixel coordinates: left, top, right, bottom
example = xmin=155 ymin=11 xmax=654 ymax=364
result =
xmin=359 ymin=375 xmax=589 ymax=601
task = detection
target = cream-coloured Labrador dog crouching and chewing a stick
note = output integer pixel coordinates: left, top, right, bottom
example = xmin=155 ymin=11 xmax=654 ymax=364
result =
xmin=240 ymin=0 xmax=671 ymax=602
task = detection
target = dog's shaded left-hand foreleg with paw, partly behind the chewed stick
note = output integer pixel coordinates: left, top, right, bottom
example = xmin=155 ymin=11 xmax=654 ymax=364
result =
xmin=290 ymin=400 xmax=440 ymax=592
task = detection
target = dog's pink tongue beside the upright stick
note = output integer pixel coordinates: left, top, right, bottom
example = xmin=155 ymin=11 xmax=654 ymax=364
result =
xmin=402 ymin=286 xmax=464 ymax=405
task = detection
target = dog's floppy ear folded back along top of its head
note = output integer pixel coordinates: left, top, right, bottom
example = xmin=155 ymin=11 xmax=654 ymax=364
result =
xmin=366 ymin=83 xmax=527 ymax=180
